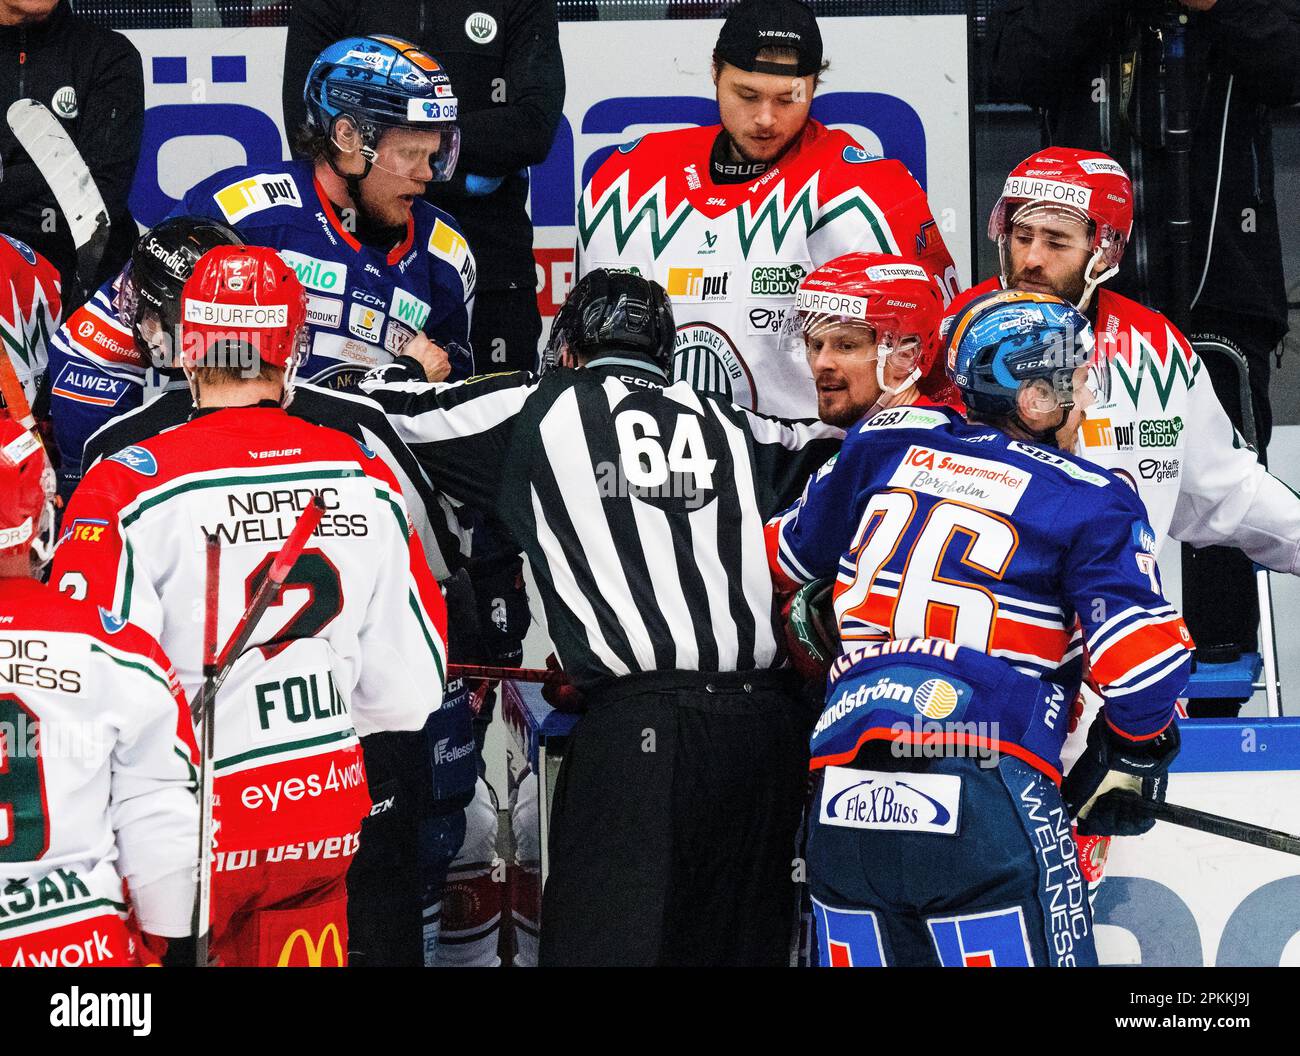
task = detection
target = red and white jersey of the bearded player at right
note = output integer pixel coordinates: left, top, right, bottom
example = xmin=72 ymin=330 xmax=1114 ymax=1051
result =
xmin=936 ymin=278 xmax=1300 ymax=575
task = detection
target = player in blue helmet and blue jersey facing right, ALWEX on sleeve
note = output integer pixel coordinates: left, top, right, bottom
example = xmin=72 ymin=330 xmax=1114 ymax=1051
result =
xmin=49 ymin=38 xmax=475 ymax=498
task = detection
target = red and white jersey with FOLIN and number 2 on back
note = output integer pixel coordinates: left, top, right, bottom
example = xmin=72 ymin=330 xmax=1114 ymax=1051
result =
xmin=52 ymin=406 xmax=446 ymax=851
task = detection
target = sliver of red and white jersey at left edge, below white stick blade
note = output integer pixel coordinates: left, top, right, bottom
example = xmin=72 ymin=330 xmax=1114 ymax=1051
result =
xmin=0 ymin=234 xmax=62 ymax=402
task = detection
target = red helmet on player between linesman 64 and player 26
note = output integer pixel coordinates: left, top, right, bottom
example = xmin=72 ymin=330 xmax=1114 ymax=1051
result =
xmin=781 ymin=254 xmax=944 ymax=394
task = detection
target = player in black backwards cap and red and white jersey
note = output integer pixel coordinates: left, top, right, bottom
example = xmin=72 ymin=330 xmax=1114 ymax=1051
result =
xmin=576 ymin=0 xmax=957 ymax=417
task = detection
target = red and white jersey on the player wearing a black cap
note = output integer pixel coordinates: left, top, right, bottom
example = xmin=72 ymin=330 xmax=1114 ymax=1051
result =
xmin=577 ymin=121 xmax=957 ymax=417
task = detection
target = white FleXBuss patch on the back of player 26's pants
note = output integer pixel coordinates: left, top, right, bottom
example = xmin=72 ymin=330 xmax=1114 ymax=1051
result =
xmin=820 ymin=766 xmax=962 ymax=835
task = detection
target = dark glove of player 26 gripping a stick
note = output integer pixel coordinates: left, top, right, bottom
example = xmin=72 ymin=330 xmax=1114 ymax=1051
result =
xmin=1061 ymin=707 xmax=1180 ymax=836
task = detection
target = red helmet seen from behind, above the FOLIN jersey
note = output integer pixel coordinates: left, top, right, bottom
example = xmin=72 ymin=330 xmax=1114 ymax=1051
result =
xmin=181 ymin=246 xmax=307 ymax=377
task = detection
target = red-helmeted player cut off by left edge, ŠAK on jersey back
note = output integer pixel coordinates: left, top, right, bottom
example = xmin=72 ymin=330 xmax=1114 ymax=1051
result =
xmin=0 ymin=416 xmax=199 ymax=968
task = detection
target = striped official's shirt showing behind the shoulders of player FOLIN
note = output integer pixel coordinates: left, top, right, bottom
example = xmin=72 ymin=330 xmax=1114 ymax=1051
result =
xmin=82 ymin=381 xmax=468 ymax=580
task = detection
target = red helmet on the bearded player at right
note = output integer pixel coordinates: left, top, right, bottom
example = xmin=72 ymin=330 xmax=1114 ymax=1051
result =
xmin=988 ymin=147 xmax=1134 ymax=308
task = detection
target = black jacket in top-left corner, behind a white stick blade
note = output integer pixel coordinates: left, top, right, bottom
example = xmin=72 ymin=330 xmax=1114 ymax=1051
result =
xmin=0 ymin=3 xmax=144 ymax=305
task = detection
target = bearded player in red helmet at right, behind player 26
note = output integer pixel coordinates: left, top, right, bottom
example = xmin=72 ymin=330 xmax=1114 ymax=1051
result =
xmin=936 ymin=147 xmax=1300 ymax=593
